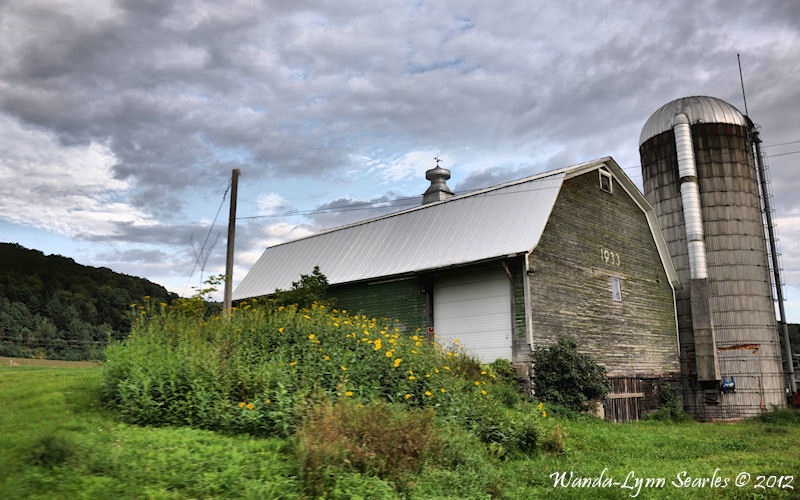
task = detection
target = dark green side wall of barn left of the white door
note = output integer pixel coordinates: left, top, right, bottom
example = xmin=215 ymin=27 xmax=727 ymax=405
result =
xmin=329 ymin=278 xmax=427 ymax=333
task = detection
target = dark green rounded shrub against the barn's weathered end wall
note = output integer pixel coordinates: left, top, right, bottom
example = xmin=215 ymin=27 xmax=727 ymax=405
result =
xmin=533 ymin=337 xmax=608 ymax=411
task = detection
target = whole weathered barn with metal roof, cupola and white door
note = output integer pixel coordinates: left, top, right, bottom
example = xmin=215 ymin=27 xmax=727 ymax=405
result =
xmin=234 ymin=157 xmax=680 ymax=420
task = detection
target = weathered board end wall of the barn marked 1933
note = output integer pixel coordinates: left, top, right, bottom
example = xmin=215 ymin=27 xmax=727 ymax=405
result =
xmin=529 ymin=171 xmax=679 ymax=376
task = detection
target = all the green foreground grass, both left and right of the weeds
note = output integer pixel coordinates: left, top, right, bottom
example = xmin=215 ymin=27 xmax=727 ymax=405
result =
xmin=0 ymin=364 xmax=800 ymax=498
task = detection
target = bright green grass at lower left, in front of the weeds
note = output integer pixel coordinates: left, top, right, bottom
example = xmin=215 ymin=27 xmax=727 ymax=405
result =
xmin=0 ymin=368 xmax=299 ymax=498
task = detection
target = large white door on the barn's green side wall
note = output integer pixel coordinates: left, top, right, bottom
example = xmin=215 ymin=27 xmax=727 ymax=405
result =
xmin=433 ymin=265 xmax=511 ymax=363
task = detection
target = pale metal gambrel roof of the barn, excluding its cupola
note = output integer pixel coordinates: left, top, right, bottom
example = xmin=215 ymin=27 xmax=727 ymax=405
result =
xmin=233 ymin=157 xmax=678 ymax=300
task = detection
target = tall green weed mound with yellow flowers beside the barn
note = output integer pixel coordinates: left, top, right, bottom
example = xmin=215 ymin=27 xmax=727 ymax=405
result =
xmin=103 ymin=302 xmax=510 ymax=436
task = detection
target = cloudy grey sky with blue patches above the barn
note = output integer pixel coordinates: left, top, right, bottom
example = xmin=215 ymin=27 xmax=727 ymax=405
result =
xmin=0 ymin=0 xmax=800 ymax=322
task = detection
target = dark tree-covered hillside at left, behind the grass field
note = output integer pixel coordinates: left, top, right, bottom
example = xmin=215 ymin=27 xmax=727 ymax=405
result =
xmin=0 ymin=243 xmax=177 ymax=360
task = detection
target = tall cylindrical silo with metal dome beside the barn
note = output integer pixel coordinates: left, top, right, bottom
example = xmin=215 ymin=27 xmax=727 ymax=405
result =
xmin=639 ymin=96 xmax=786 ymax=420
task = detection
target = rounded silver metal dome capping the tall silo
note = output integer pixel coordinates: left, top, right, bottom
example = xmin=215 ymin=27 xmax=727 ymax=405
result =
xmin=639 ymin=96 xmax=747 ymax=146
